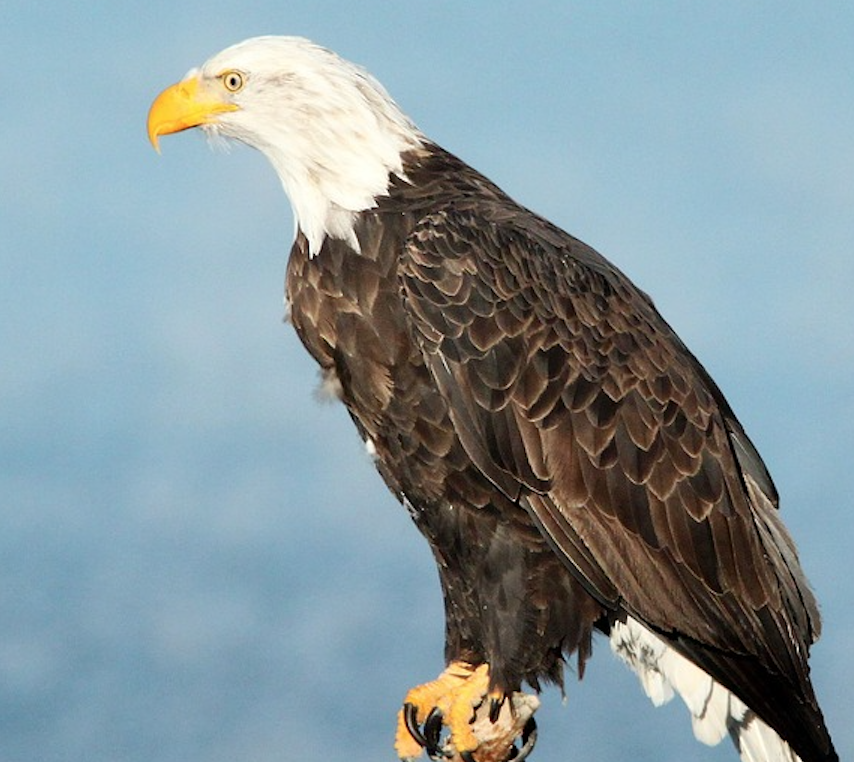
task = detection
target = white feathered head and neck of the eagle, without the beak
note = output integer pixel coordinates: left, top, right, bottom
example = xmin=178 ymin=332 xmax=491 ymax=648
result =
xmin=191 ymin=37 xmax=424 ymax=254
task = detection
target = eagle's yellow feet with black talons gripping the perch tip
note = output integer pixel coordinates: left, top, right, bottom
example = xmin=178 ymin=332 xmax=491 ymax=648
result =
xmin=395 ymin=662 xmax=539 ymax=762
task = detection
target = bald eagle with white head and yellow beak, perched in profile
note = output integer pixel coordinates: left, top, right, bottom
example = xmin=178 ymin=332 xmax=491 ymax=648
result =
xmin=148 ymin=37 xmax=837 ymax=762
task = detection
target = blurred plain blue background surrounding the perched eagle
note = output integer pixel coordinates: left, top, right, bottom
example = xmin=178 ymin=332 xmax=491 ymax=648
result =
xmin=0 ymin=0 xmax=854 ymax=762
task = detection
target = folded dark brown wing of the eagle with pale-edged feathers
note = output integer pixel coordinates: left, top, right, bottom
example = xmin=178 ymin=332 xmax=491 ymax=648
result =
xmin=402 ymin=200 xmax=826 ymax=747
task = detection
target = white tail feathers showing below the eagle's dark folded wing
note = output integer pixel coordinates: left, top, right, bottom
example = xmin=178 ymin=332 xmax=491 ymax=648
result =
xmin=611 ymin=617 xmax=800 ymax=762
